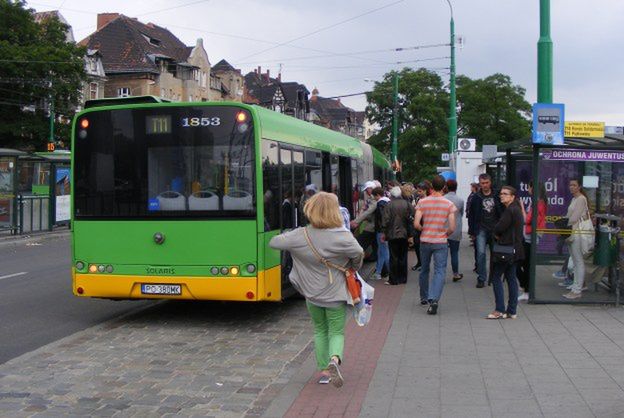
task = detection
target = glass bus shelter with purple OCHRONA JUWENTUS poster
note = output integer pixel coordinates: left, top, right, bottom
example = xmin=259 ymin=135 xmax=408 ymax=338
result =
xmin=503 ymin=134 xmax=624 ymax=304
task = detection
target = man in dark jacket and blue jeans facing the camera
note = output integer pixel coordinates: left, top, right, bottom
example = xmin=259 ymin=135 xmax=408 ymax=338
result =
xmin=468 ymin=173 xmax=504 ymax=288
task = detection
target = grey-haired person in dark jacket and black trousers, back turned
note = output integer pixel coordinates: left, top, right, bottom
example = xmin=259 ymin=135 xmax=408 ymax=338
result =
xmin=382 ymin=186 xmax=414 ymax=285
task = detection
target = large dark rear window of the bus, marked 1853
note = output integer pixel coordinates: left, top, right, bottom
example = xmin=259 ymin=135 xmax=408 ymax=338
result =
xmin=74 ymin=106 xmax=255 ymax=219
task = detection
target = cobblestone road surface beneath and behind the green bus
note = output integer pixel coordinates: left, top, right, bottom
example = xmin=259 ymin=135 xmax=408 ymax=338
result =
xmin=0 ymin=300 xmax=312 ymax=417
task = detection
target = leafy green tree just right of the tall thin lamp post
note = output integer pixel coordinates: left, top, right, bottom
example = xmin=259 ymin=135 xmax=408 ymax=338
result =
xmin=457 ymin=74 xmax=531 ymax=145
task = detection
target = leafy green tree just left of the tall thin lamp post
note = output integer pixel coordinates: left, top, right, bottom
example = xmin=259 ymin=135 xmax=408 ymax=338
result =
xmin=366 ymin=68 xmax=449 ymax=180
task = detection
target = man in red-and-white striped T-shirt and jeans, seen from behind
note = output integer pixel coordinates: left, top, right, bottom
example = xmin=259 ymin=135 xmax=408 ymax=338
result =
xmin=414 ymin=176 xmax=457 ymax=315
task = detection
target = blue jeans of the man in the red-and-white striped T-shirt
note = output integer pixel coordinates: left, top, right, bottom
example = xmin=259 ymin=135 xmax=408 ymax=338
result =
xmin=419 ymin=242 xmax=448 ymax=301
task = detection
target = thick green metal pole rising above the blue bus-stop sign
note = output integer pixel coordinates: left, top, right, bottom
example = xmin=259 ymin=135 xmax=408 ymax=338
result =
xmin=537 ymin=0 xmax=553 ymax=103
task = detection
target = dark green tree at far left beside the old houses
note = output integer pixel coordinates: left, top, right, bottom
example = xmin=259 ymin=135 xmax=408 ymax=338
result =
xmin=0 ymin=0 xmax=86 ymax=150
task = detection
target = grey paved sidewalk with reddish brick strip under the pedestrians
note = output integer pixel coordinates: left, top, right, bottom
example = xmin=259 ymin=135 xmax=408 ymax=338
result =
xmin=264 ymin=242 xmax=624 ymax=418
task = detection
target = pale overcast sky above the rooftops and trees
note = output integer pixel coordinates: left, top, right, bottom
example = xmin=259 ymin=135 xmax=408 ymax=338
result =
xmin=27 ymin=0 xmax=624 ymax=126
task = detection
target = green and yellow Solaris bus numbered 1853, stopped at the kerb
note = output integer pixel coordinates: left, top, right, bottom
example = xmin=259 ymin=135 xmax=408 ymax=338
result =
xmin=71 ymin=101 xmax=391 ymax=301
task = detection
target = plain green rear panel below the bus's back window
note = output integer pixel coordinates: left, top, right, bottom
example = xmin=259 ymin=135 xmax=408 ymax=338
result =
xmin=73 ymin=220 xmax=258 ymax=268
